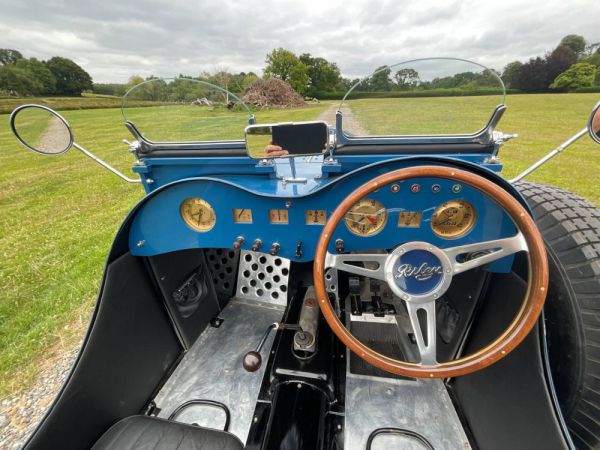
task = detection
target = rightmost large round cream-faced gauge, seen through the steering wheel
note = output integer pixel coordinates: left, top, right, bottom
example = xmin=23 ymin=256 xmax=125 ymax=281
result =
xmin=431 ymin=200 xmax=475 ymax=239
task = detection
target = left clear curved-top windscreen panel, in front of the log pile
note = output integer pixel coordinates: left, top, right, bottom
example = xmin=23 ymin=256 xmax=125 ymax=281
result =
xmin=122 ymin=78 xmax=252 ymax=142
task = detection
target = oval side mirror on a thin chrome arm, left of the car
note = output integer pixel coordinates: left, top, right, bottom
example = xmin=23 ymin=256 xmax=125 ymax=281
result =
xmin=10 ymin=105 xmax=73 ymax=155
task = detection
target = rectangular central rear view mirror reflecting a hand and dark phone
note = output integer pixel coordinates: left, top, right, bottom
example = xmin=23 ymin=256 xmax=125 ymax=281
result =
xmin=245 ymin=122 xmax=329 ymax=159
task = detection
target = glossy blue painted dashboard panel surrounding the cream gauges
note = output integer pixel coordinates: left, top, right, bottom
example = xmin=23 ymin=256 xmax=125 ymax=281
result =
xmin=129 ymin=162 xmax=515 ymax=271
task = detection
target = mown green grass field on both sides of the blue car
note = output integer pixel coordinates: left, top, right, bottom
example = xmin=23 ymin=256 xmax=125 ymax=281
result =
xmin=0 ymin=94 xmax=600 ymax=397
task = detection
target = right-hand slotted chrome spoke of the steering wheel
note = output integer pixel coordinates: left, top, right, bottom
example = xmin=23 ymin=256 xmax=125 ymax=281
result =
xmin=442 ymin=233 xmax=529 ymax=275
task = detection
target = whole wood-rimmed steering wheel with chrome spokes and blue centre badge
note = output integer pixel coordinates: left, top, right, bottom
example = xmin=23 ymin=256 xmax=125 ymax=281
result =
xmin=313 ymin=166 xmax=548 ymax=378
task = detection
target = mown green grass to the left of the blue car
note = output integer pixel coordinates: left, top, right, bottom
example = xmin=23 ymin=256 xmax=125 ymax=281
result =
xmin=0 ymin=100 xmax=329 ymax=398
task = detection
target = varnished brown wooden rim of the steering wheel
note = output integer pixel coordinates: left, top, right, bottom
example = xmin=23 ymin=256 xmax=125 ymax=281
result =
xmin=313 ymin=166 xmax=548 ymax=378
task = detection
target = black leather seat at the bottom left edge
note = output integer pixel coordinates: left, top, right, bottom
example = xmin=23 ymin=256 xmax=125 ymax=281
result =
xmin=92 ymin=416 xmax=244 ymax=450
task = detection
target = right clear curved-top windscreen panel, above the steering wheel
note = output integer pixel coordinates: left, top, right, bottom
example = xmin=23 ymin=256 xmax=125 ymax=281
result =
xmin=339 ymin=58 xmax=505 ymax=136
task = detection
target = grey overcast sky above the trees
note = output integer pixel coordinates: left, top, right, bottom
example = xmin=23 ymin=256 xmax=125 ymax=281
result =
xmin=0 ymin=0 xmax=600 ymax=82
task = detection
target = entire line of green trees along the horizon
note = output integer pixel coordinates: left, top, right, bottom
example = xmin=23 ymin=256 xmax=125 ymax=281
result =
xmin=0 ymin=34 xmax=600 ymax=97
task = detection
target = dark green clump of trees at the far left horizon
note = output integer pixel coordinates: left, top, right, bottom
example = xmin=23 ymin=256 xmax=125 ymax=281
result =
xmin=0 ymin=48 xmax=93 ymax=96
